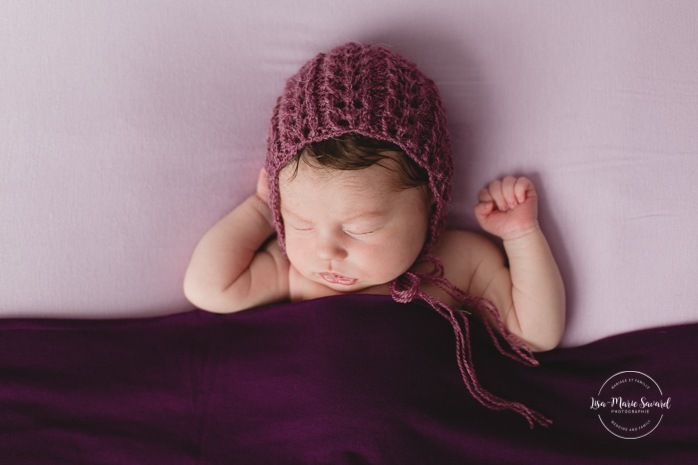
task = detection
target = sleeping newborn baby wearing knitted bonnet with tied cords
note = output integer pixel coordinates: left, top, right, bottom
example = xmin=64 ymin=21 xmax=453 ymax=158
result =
xmin=184 ymin=43 xmax=565 ymax=426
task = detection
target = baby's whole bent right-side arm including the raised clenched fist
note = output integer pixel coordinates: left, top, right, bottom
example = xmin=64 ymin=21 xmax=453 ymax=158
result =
xmin=474 ymin=176 xmax=565 ymax=350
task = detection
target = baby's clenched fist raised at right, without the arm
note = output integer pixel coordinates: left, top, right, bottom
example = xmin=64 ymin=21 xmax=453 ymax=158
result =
xmin=475 ymin=176 xmax=538 ymax=240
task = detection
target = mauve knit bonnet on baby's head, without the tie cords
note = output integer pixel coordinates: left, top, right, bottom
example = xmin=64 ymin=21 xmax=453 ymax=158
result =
xmin=265 ymin=43 xmax=453 ymax=252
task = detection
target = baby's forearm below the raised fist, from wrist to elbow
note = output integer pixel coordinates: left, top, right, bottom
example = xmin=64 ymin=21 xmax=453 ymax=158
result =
xmin=504 ymin=227 xmax=565 ymax=350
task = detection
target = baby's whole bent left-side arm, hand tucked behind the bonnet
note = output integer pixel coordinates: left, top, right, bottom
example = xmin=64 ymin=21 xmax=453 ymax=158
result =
xmin=184 ymin=170 xmax=288 ymax=313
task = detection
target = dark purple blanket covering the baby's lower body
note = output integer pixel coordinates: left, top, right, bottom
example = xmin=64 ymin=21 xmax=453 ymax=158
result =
xmin=0 ymin=296 xmax=698 ymax=465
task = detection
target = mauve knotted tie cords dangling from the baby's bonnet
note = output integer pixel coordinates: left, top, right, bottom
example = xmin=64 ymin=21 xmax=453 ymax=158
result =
xmin=391 ymin=254 xmax=552 ymax=429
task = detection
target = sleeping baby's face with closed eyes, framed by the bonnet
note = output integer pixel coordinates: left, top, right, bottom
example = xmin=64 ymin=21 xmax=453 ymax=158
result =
xmin=279 ymin=160 xmax=429 ymax=292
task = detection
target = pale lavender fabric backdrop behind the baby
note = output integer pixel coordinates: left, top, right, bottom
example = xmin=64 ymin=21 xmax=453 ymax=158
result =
xmin=0 ymin=0 xmax=698 ymax=346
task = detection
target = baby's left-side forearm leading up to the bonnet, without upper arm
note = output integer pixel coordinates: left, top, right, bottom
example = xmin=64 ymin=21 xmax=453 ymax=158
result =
xmin=184 ymin=195 xmax=274 ymax=300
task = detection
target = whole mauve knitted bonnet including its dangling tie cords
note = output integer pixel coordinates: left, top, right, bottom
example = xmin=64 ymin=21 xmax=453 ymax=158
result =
xmin=265 ymin=43 xmax=550 ymax=427
